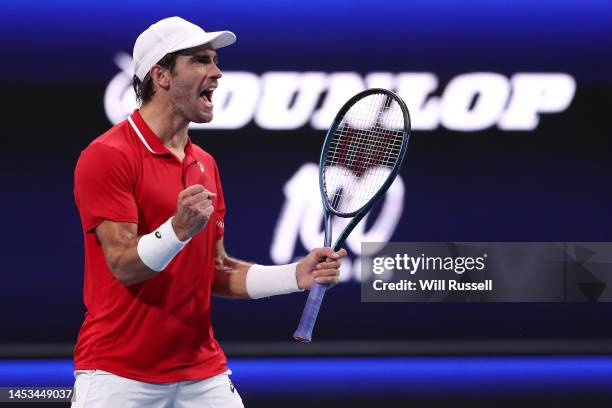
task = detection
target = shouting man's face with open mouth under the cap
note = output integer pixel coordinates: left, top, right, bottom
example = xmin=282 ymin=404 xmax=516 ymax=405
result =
xmin=170 ymin=46 xmax=221 ymax=123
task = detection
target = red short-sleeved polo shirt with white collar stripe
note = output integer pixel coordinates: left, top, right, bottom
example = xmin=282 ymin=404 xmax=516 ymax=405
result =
xmin=74 ymin=110 xmax=227 ymax=383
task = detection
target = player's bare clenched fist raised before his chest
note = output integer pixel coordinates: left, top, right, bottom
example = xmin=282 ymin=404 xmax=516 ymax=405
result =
xmin=172 ymin=184 xmax=216 ymax=241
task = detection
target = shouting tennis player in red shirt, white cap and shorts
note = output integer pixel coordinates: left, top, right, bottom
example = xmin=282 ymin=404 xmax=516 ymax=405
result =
xmin=73 ymin=17 xmax=346 ymax=408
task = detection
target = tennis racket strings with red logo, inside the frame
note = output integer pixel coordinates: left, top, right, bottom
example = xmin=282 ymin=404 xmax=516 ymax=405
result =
xmin=323 ymin=93 xmax=405 ymax=213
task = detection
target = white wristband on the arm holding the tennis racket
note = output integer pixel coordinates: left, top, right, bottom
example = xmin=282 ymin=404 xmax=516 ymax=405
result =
xmin=246 ymin=262 xmax=304 ymax=299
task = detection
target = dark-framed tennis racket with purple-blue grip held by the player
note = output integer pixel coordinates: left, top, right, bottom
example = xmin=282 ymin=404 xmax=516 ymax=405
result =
xmin=293 ymin=88 xmax=410 ymax=343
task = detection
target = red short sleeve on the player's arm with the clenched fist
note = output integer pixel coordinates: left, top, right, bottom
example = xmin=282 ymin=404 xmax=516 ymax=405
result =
xmin=74 ymin=143 xmax=138 ymax=232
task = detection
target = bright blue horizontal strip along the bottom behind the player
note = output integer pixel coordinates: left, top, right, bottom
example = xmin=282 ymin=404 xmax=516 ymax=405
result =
xmin=0 ymin=356 xmax=612 ymax=400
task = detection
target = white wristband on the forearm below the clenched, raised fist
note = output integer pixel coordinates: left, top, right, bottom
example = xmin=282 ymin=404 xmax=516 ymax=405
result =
xmin=136 ymin=217 xmax=191 ymax=272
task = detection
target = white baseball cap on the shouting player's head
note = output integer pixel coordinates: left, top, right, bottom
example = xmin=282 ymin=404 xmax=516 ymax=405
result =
xmin=134 ymin=17 xmax=236 ymax=81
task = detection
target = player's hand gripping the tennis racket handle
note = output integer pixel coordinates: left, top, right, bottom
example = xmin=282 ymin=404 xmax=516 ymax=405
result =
xmin=295 ymin=248 xmax=346 ymax=289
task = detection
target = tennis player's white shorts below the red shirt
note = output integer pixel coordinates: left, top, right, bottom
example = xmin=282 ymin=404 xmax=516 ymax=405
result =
xmin=72 ymin=370 xmax=244 ymax=408
